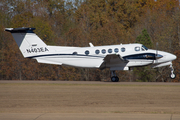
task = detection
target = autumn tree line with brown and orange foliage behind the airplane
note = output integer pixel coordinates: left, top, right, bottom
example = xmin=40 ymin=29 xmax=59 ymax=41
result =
xmin=0 ymin=0 xmax=180 ymax=82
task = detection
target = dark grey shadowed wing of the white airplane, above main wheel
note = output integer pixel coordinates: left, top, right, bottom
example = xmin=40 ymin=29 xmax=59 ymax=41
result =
xmin=99 ymin=54 xmax=129 ymax=70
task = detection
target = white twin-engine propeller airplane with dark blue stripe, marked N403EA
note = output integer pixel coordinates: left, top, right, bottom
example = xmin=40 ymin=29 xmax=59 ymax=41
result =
xmin=5 ymin=27 xmax=176 ymax=82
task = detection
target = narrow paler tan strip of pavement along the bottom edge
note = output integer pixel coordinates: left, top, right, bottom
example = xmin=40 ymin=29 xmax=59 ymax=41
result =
xmin=0 ymin=113 xmax=180 ymax=120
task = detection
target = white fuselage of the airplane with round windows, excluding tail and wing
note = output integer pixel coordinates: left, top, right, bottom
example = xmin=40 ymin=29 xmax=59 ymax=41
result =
xmin=29 ymin=44 xmax=176 ymax=69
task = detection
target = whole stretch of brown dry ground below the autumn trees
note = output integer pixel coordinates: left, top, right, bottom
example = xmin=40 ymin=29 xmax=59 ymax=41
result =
xmin=0 ymin=81 xmax=180 ymax=120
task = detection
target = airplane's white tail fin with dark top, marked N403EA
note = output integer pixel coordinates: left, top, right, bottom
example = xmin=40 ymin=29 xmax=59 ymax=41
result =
xmin=5 ymin=28 xmax=49 ymax=57
